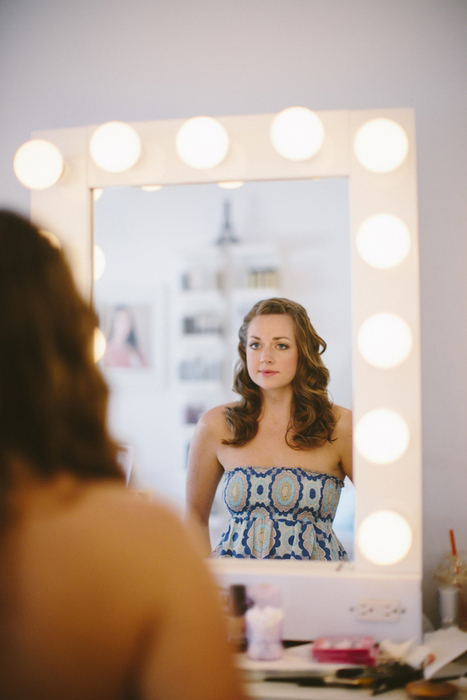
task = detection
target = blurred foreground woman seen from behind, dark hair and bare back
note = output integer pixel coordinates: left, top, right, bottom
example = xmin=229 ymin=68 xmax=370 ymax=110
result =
xmin=0 ymin=211 xmax=245 ymax=700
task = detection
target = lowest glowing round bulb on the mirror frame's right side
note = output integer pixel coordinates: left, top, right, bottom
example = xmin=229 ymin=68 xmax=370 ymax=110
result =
xmin=357 ymin=510 xmax=413 ymax=566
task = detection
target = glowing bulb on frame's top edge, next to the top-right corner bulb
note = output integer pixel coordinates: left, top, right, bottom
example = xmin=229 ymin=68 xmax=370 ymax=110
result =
xmin=270 ymin=107 xmax=324 ymax=160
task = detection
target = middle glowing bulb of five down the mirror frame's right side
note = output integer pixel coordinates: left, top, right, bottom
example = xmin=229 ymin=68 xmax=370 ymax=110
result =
xmin=357 ymin=312 xmax=412 ymax=369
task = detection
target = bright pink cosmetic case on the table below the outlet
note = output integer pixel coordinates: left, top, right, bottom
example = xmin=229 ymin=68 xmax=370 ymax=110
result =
xmin=311 ymin=635 xmax=378 ymax=666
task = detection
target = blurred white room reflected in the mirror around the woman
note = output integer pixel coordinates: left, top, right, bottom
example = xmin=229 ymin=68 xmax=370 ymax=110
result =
xmin=94 ymin=178 xmax=354 ymax=558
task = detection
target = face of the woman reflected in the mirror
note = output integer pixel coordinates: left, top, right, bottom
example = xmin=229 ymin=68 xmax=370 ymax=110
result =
xmin=246 ymin=314 xmax=298 ymax=391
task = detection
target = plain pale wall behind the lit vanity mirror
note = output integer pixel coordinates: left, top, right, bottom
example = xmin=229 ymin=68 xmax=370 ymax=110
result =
xmin=0 ymin=0 xmax=467 ymax=624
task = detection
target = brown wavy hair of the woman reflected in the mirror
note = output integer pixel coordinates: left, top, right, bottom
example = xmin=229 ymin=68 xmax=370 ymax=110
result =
xmin=223 ymin=298 xmax=336 ymax=450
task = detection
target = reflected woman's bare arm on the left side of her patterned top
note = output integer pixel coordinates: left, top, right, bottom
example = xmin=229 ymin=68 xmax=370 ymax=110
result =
xmin=186 ymin=406 xmax=225 ymax=556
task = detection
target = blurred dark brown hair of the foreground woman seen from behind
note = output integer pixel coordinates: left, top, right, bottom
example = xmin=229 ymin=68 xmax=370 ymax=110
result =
xmin=0 ymin=210 xmax=124 ymax=511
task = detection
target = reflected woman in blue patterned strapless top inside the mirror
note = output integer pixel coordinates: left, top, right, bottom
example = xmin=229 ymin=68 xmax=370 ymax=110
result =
xmin=187 ymin=298 xmax=352 ymax=560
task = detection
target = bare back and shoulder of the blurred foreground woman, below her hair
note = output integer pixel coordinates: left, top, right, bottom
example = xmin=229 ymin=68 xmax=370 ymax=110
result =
xmin=21 ymin=484 xmax=247 ymax=700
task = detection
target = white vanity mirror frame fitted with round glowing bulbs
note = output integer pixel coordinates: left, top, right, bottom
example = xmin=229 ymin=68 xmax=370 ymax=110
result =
xmin=27 ymin=109 xmax=421 ymax=639
